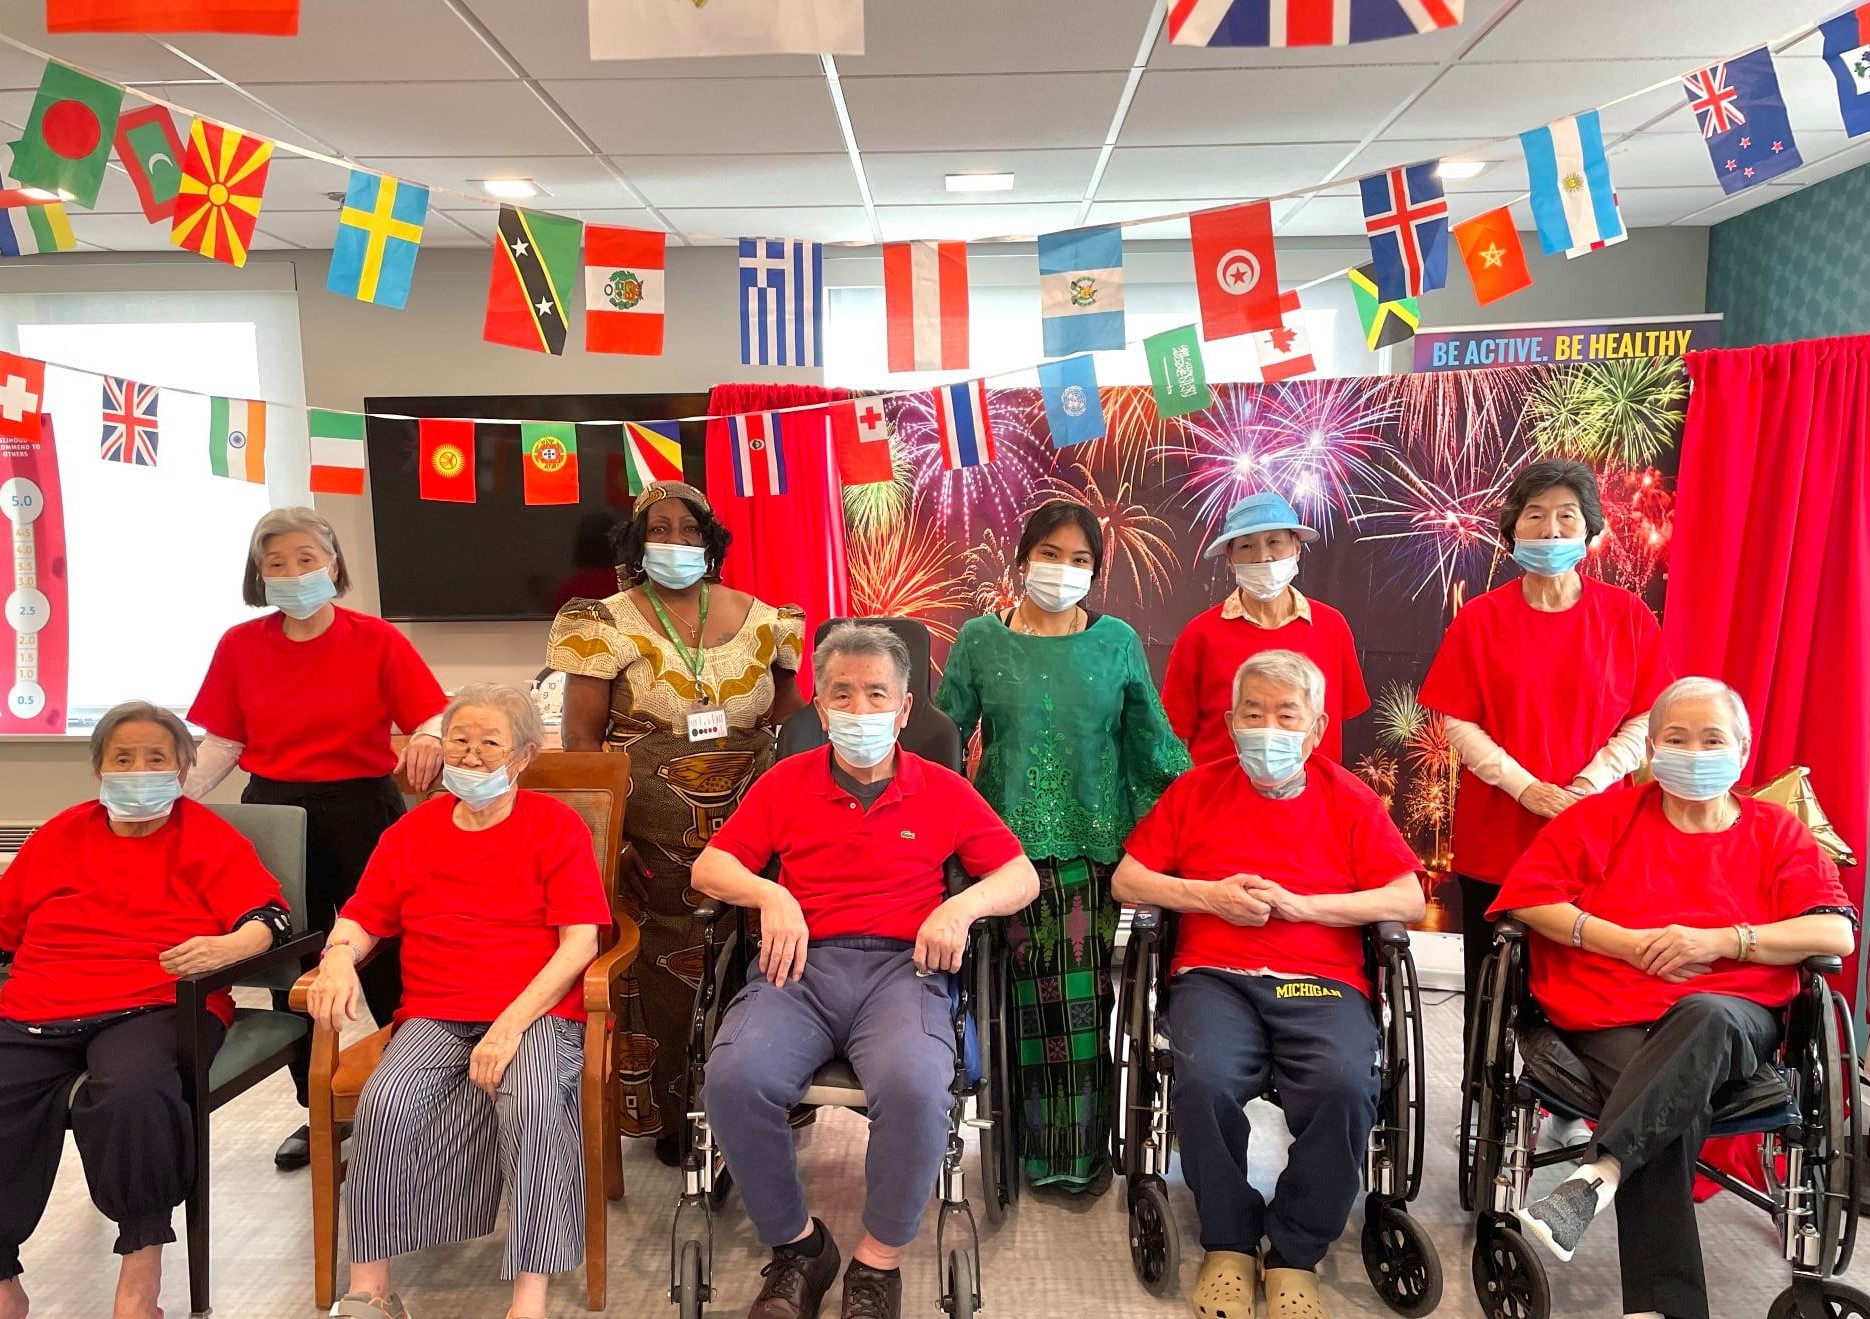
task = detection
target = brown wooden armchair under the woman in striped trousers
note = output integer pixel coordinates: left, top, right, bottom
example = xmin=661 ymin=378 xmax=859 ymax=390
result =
xmin=292 ymin=750 xmax=638 ymax=1310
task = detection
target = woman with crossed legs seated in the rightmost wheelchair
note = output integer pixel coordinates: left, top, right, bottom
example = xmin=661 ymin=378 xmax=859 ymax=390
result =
xmin=1489 ymin=677 xmax=1855 ymax=1319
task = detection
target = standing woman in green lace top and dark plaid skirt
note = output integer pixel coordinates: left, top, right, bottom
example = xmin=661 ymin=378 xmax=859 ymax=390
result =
xmin=935 ymin=500 xmax=1189 ymax=1194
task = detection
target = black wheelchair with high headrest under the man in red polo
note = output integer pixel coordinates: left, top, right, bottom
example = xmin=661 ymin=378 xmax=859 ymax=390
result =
xmin=669 ymin=617 xmax=1019 ymax=1319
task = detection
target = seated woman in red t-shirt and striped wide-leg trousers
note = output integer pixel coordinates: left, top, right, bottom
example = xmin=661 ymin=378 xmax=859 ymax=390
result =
xmin=309 ymin=683 xmax=610 ymax=1319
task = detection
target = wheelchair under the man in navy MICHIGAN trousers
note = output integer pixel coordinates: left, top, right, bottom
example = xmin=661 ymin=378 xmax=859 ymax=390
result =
xmin=1111 ymin=906 xmax=1442 ymax=1319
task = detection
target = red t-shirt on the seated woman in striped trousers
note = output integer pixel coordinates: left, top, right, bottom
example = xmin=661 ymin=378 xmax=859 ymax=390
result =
xmin=338 ymin=790 xmax=610 ymax=1022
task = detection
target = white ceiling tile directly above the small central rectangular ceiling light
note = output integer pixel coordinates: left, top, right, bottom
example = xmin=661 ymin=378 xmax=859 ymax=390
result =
xmin=843 ymin=73 xmax=1126 ymax=152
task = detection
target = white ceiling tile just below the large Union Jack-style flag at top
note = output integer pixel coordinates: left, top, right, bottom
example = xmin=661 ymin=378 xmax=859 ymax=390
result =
xmin=1118 ymin=65 xmax=1431 ymax=146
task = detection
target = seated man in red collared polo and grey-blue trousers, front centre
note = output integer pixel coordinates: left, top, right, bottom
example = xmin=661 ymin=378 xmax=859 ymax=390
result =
xmin=694 ymin=623 xmax=1040 ymax=1319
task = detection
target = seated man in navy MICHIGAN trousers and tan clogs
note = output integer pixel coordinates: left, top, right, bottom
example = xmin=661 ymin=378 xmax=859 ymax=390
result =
xmin=1113 ymin=651 xmax=1423 ymax=1319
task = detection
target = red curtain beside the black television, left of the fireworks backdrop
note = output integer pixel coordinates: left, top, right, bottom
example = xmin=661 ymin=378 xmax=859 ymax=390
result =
xmin=707 ymin=377 xmax=851 ymax=694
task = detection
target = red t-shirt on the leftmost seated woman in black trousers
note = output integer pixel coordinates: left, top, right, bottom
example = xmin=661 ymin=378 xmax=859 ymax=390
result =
xmin=0 ymin=799 xmax=286 ymax=1023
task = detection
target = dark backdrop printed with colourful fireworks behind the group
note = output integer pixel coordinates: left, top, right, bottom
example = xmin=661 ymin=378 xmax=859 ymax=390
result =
xmin=860 ymin=359 xmax=1687 ymax=928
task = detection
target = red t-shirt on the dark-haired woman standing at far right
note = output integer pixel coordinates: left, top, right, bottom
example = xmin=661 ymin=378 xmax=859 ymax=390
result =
xmin=1419 ymin=576 xmax=1670 ymax=883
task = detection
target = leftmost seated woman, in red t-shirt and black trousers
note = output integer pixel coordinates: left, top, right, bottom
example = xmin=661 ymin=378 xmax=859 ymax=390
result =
xmin=0 ymin=702 xmax=292 ymax=1319
